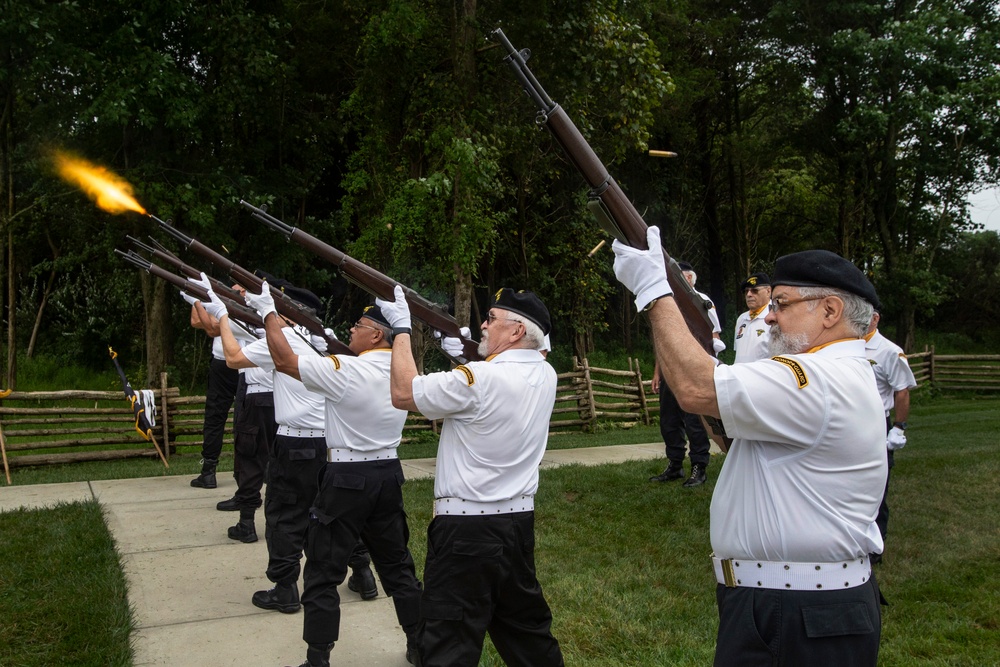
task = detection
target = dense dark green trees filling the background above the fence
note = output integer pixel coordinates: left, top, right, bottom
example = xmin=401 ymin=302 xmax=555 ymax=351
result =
xmin=0 ymin=0 xmax=1000 ymax=386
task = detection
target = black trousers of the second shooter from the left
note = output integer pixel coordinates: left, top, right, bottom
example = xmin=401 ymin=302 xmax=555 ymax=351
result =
xmin=233 ymin=391 xmax=278 ymax=510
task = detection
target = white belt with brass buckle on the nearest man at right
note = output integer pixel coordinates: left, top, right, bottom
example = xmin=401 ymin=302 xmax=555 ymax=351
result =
xmin=712 ymin=556 xmax=872 ymax=591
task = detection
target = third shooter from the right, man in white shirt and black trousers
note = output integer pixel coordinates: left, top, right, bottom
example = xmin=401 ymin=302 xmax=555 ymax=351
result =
xmin=262 ymin=304 xmax=421 ymax=667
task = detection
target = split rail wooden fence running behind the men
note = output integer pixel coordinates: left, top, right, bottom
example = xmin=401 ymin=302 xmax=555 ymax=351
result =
xmin=0 ymin=348 xmax=1000 ymax=478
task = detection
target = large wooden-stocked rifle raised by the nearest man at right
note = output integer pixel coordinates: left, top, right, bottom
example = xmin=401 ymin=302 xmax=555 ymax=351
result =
xmin=493 ymin=28 xmax=728 ymax=451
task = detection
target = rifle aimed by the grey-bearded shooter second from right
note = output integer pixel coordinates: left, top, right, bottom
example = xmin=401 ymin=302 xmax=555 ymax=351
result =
xmin=240 ymin=201 xmax=480 ymax=362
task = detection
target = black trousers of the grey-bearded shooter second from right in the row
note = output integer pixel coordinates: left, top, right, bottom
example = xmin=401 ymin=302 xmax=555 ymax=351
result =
xmin=421 ymin=512 xmax=563 ymax=667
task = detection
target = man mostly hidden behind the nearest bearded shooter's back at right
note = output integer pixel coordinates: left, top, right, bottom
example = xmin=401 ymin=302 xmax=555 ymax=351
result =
xmin=865 ymin=311 xmax=917 ymax=563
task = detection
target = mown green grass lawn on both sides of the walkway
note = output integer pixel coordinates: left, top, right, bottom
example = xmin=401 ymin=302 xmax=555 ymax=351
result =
xmin=0 ymin=397 xmax=1000 ymax=667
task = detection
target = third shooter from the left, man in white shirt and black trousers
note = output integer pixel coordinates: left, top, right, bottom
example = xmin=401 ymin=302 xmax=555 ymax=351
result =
xmin=221 ymin=281 xmax=377 ymax=614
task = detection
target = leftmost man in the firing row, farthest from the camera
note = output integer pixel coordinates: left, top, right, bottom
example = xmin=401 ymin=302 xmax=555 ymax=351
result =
xmin=181 ymin=276 xmax=240 ymax=489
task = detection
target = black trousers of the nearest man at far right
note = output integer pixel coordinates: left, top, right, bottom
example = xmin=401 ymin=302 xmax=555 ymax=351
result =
xmin=715 ymin=572 xmax=882 ymax=667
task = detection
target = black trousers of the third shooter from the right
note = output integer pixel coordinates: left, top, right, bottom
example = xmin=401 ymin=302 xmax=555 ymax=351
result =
xmin=302 ymin=459 xmax=420 ymax=644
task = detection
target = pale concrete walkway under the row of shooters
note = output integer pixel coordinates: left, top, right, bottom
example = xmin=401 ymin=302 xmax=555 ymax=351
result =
xmin=0 ymin=443 xmax=664 ymax=667
